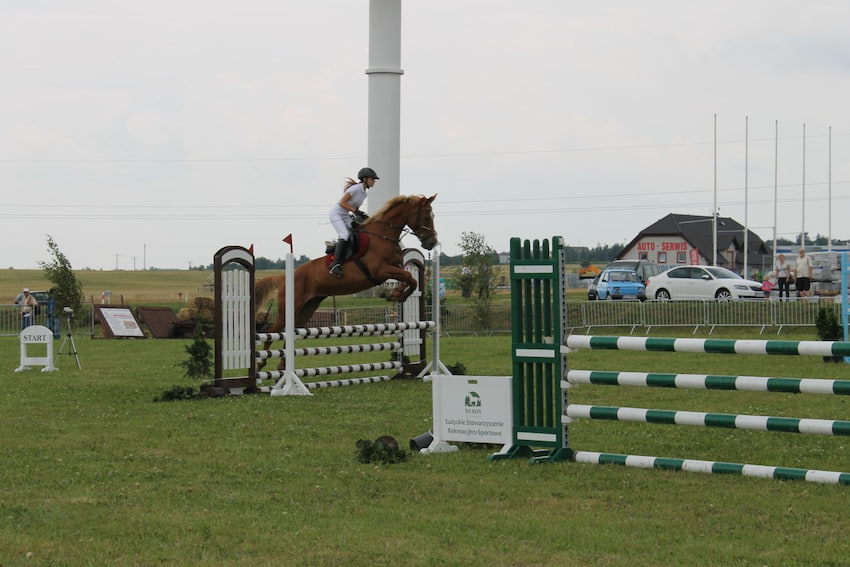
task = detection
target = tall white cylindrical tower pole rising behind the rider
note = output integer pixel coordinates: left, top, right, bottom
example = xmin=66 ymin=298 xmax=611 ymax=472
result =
xmin=366 ymin=0 xmax=404 ymax=213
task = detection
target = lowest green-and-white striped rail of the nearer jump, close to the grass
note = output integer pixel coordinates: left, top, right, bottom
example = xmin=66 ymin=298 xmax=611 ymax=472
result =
xmin=572 ymin=451 xmax=850 ymax=485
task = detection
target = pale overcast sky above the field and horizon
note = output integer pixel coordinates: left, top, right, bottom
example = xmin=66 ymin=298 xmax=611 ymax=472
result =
xmin=0 ymin=0 xmax=850 ymax=270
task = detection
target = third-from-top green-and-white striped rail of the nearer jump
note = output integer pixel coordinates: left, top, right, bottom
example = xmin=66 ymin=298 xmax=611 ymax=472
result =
xmin=563 ymin=404 xmax=850 ymax=436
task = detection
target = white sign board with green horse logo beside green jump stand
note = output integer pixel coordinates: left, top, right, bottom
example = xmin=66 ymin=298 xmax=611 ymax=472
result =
xmin=433 ymin=375 xmax=513 ymax=444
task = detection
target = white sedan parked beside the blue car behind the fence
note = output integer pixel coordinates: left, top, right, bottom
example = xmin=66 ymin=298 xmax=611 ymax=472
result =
xmin=646 ymin=266 xmax=764 ymax=301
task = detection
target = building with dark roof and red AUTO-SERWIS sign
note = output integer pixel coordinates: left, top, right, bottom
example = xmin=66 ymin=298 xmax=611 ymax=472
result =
xmin=617 ymin=213 xmax=772 ymax=274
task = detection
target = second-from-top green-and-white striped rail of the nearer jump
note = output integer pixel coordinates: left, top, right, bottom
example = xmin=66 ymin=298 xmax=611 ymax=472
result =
xmin=561 ymin=370 xmax=850 ymax=396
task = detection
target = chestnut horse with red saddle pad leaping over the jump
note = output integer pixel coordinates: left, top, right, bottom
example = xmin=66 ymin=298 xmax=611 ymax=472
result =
xmin=254 ymin=195 xmax=437 ymax=368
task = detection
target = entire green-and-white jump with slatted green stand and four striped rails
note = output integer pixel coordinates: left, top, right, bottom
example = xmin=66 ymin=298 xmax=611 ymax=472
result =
xmin=490 ymin=237 xmax=850 ymax=485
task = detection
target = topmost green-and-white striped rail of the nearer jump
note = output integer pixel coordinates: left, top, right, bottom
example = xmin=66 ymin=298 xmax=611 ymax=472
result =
xmin=566 ymin=335 xmax=850 ymax=356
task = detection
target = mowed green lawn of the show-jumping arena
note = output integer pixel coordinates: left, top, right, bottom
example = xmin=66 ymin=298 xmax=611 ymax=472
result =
xmin=0 ymin=334 xmax=850 ymax=567
